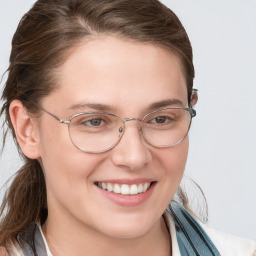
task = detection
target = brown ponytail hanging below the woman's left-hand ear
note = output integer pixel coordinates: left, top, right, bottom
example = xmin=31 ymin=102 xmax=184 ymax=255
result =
xmin=0 ymin=159 xmax=47 ymax=246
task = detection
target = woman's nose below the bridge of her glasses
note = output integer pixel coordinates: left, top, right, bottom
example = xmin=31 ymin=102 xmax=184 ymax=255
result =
xmin=112 ymin=123 xmax=152 ymax=171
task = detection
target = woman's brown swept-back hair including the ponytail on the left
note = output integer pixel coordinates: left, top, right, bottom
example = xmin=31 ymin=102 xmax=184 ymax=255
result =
xmin=0 ymin=0 xmax=194 ymax=246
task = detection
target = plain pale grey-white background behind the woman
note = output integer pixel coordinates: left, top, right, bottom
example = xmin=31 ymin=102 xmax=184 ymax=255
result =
xmin=0 ymin=0 xmax=256 ymax=239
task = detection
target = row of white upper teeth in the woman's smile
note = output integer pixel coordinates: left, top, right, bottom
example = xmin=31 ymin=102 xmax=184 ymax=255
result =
xmin=97 ymin=182 xmax=150 ymax=195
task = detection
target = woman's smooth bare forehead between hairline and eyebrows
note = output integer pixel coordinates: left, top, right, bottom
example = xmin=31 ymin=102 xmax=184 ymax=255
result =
xmin=46 ymin=37 xmax=187 ymax=114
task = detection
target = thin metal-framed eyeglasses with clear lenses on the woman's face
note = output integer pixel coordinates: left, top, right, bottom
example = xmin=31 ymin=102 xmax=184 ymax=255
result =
xmin=43 ymin=107 xmax=196 ymax=153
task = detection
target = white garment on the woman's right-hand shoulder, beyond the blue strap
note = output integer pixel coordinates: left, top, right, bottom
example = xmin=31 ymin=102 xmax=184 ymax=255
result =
xmin=200 ymin=223 xmax=256 ymax=256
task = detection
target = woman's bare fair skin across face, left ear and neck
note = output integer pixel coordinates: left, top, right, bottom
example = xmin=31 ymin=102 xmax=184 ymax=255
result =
xmin=10 ymin=37 xmax=194 ymax=256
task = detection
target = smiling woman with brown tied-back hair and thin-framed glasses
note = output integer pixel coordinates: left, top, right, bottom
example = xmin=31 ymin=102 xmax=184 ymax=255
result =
xmin=0 ymin=0 xmax=255 ymax=256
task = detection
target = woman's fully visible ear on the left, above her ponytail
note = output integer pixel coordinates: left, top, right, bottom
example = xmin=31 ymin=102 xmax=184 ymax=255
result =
xmin=9 ymin=100 xmax=40 ymax=159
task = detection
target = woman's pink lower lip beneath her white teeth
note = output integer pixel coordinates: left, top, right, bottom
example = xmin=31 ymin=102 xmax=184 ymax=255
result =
xmin=95 ymin=182 xmax=156 ymax=207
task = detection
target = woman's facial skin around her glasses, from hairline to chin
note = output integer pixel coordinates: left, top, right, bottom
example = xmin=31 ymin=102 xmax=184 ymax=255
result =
xmin=38 ymin=37 xmax=188 ymax=238
